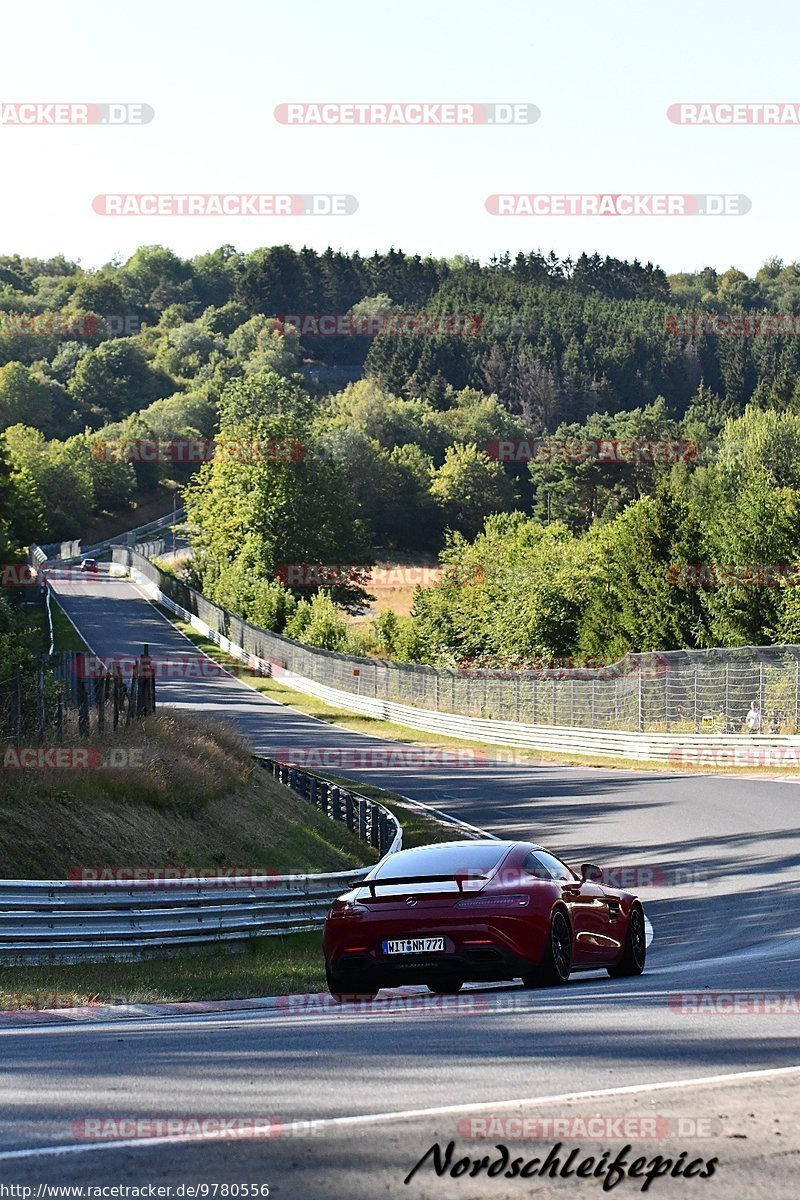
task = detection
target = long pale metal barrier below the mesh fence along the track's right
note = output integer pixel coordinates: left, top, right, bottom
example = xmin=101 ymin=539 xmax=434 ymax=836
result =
xmin=116 ymin=551 xmax=800 ymax=767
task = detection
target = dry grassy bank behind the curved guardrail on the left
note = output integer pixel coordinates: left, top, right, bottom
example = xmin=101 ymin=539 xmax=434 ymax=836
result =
xmin=0 ymin=709 xmax=377 ymax=880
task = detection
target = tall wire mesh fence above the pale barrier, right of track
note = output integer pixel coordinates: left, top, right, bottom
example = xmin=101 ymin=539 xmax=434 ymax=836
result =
xmin=113 ymin=547 xmax=800 ymax=734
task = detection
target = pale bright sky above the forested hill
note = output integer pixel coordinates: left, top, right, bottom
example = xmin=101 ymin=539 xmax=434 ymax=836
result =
xmin=0 ymin=0 xmax=800 ymax=274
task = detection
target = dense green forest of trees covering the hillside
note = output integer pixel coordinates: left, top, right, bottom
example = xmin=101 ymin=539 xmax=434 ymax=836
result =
xmin=0 ymin=246 xmax=800 ymax=664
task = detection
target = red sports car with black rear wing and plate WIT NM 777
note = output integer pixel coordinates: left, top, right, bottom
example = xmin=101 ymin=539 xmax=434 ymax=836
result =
xmin=323 ymin=841 xmax=646 ymax=997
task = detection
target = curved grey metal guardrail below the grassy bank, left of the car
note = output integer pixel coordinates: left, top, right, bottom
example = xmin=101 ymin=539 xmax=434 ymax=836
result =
xmin=0 ymin=758 xmax=403 ymax=965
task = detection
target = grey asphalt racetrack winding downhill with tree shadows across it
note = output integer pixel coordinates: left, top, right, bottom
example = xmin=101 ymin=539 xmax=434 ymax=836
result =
xmin=0 ymin=576 xmax=800 ymax=1200
